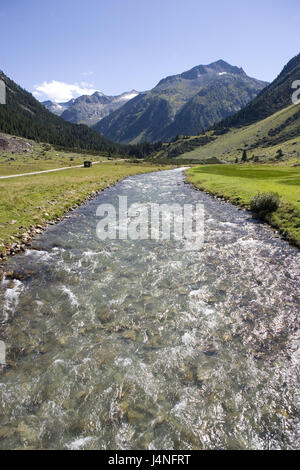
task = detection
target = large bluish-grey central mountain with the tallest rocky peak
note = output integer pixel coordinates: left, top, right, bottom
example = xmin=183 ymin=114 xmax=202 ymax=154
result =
xmin=94 ymin=60 xmax=266 ymax=143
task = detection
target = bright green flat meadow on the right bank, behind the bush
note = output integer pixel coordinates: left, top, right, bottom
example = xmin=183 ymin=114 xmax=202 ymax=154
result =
xmin=186 ymin=165 xmax=300 ymax=247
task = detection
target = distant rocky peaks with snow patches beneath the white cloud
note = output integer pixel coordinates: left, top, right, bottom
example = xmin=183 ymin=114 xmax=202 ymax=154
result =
xmin=42 ymin=90 xmax=139 ymax=127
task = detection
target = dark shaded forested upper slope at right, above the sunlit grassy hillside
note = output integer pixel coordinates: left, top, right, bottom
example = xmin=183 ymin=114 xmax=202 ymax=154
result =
xmin=216 ymin=54 xmax=300 ymax=128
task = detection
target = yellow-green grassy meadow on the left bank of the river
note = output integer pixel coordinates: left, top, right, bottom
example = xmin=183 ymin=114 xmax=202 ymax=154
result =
xmin=0 ymin=162 xmax=168 ymax=253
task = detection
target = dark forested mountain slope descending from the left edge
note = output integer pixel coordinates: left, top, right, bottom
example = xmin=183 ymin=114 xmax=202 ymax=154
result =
xmin=0 ymin=72 xmax=120 ymax=152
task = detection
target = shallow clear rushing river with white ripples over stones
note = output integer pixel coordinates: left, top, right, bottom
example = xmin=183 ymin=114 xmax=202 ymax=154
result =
xmin=0 ymin=170 xmax=300 ymax=449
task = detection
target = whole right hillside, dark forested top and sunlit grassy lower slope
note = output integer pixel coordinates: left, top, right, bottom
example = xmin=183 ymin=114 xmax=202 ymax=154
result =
xmin=155 ymin=54 xmax=300 ymax=163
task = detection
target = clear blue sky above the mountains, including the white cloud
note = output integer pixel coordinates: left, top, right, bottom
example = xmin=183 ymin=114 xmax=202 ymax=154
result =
xmin=0 ymin=0 xmax=300 ymax=101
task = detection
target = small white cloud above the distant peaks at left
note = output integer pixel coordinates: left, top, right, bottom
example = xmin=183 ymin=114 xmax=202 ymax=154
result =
xmin=33 ymin=80 xmax=97 ymax=103
